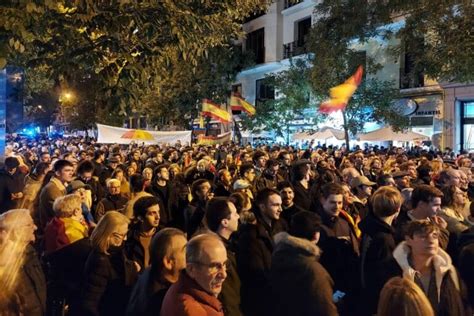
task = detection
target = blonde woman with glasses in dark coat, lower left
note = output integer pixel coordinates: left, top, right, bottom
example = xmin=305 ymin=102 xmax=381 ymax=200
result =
xmin=77 ymin=211 xmax=138 ymax=315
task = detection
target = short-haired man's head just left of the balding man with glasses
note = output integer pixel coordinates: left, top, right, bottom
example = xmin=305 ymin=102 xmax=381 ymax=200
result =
xmin=150 ymin=228 xmax=187 ymax=281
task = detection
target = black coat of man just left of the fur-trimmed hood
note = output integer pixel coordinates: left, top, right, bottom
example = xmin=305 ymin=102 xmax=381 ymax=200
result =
xmin=237 ymin=218 xmax=283 ymax=316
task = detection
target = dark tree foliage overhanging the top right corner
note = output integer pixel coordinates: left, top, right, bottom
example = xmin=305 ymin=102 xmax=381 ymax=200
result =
xmin=313 ymin=0 xmax=474 ymax=82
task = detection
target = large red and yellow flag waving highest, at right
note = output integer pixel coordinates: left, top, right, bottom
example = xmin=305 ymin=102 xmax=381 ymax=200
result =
xmin=319 ymin=66 xmax=364 ymax=113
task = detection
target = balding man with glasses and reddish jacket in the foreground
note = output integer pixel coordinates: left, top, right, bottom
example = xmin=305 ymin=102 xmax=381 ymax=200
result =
xmin=160 ymin=234 xmax=227 ymax=316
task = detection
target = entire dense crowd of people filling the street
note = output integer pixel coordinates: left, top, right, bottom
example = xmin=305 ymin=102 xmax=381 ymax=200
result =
xmin=0 ymin=138 xmax=474 ymax=316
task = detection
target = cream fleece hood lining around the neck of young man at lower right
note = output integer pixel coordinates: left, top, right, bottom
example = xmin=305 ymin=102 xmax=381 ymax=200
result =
xmin=393 ymin=241 xmax=460 ymax=299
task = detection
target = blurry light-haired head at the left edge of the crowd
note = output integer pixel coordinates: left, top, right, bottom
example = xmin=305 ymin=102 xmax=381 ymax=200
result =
xmin=0 ymin=209 xmax=37 ymax=247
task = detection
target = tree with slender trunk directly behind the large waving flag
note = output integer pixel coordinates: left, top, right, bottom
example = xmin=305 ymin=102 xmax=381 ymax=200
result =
xmin=307 ymin=0 xmax=408 ymax=148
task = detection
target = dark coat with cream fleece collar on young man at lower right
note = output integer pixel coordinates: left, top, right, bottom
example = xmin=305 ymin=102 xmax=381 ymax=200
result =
xmin=393 ymin=242 xmax=465 ymax=316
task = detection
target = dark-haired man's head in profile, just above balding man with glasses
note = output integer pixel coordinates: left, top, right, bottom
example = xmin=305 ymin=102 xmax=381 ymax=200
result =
xmin=206 ymin=197 xmax=239 ymax=233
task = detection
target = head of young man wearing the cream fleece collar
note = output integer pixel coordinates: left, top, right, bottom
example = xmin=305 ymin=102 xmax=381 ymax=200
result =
xmin=405 ymin=220 xmax=439 ymax=258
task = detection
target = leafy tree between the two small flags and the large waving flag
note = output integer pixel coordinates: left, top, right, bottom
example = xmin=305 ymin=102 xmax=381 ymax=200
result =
xmin=242 ymin=56 xmax=322 ymax=142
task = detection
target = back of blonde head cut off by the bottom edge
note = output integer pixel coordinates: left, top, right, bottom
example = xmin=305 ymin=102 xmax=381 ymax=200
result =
xmin=377 ymin=277 xmax=434 ymax=316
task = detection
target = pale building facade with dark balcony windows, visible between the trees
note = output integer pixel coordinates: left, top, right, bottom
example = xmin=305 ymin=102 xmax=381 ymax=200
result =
xmin=237 ymin=0 xmax=474 ymax=151
